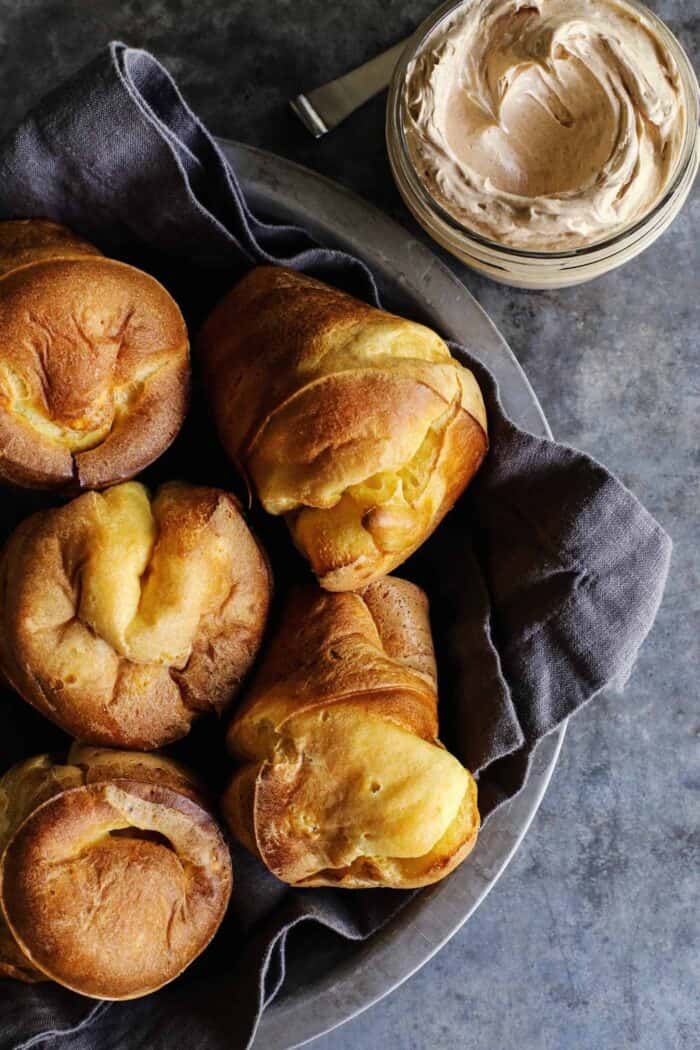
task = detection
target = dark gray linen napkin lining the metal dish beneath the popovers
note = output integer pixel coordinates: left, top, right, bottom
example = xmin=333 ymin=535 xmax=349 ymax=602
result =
xmin=0 ymin=44 xmax=671 ymax=1050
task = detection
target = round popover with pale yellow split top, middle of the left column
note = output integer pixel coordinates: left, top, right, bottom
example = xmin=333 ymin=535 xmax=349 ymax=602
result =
xmin=0 ymin=482 xmax=271 ymax=749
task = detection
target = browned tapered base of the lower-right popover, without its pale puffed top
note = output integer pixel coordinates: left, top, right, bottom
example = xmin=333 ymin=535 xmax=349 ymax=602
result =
xmin=227 ymin=576 xmax=438 ymax=759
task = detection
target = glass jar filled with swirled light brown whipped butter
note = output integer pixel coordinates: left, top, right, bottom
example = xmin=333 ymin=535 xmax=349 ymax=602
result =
xmin=386 ymin=0 xmax=700 ymax=289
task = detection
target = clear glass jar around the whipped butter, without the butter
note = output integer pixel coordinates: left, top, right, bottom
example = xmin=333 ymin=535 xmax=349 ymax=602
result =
xmin=386 ymin=0 xmax=700 ymax=289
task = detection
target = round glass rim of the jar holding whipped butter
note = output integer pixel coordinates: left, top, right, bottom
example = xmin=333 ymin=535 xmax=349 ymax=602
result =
xmin=386 ymin=0 xmax=700 ymax=261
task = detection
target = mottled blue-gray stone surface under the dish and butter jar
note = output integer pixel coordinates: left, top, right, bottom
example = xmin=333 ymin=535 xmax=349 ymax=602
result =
xmin=0 ymin=0 xmax=700 ymax=1050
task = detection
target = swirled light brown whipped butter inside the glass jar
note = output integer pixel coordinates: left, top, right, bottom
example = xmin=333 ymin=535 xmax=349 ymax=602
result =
xmin=403 ymin=0 xmax=687 ymax=252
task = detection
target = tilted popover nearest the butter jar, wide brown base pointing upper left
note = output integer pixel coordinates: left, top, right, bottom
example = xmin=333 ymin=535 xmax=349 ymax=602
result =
xmin=198 ymin=267 xmax=487 ymax=591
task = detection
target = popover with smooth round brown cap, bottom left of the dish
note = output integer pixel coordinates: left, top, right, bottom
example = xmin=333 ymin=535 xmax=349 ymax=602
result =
xmin=0 ymin=744 xmax=232 ymax=999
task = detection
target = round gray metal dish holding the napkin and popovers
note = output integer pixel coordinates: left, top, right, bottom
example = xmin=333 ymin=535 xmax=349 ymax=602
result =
xmin=220 ymin=141 xmax=565 ymax=1050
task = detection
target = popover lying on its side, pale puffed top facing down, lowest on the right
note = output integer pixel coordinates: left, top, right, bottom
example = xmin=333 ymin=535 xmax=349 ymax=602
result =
xmin=222 ymin=576 xmax=480 ymax=888
